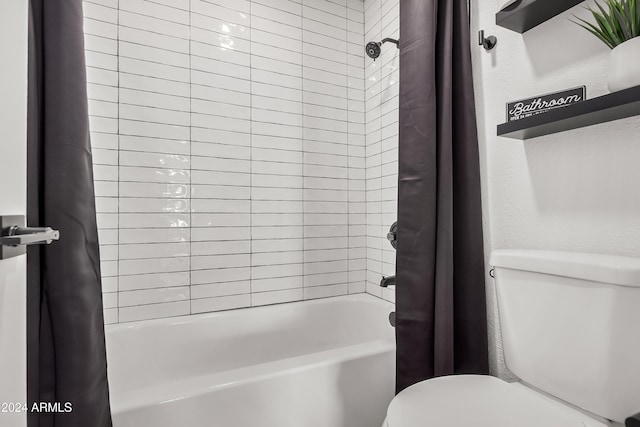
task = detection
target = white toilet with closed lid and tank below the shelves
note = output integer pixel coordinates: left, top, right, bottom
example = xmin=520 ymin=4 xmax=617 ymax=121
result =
xmin=383 ymin=250 xmax=640 ymax=427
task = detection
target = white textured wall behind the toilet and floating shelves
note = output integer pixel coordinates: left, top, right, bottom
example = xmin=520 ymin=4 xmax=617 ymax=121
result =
xmin=472 ymin=0 xmax=640 ymax=374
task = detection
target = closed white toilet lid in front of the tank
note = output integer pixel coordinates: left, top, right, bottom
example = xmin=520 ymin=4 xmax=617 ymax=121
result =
xmin=387 ymin=375 xmax=606 ymax=427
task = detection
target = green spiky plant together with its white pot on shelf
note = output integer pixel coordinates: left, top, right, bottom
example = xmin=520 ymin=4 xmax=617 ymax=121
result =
xmin=576 ymin=0 xmax=640 ymax=92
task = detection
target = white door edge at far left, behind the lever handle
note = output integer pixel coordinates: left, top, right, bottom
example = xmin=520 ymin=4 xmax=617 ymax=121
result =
xmin=0 ymin=0 xmax=28 ymax=427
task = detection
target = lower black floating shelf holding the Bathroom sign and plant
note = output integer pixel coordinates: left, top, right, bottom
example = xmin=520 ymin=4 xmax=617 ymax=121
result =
xmin=498 ymin=86 xmax=640 ymax=139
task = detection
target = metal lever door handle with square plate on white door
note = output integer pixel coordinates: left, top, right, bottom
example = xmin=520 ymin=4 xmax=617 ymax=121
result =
xmin=0 ymin=215 xmax=60 ymax=259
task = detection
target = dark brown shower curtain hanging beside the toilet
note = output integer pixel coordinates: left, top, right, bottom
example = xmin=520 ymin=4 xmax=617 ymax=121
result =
xmin=396 ymin=0 xmax=488 ymax=392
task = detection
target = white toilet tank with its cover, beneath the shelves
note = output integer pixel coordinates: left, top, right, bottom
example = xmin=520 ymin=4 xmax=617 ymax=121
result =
xmin=490 ymin=250 xmax=640 ymax=422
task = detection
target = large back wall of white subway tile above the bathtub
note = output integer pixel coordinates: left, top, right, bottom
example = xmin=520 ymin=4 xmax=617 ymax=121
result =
xmin=84 ymin=0 xmax=367 ymax=323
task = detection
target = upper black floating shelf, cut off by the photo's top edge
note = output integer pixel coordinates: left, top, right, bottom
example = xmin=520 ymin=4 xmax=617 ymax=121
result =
xmin=496 ymin=0 xmax=584 ymax=34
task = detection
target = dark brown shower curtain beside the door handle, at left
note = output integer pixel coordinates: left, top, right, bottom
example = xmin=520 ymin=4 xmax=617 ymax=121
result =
xmin=27 ymin=0 xmax=111 ymax=427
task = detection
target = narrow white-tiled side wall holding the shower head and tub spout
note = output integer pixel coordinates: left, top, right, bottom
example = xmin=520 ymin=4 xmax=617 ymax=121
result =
xmin=364 ymin=0 xmax=400 ymax=301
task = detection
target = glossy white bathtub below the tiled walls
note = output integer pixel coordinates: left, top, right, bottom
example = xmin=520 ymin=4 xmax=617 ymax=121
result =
xmin=106 ymin=294 xmax=395 ymax=427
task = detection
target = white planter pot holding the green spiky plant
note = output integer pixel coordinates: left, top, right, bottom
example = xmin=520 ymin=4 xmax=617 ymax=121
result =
xmin=609 ymin=37 xmax=640 ymax=92
